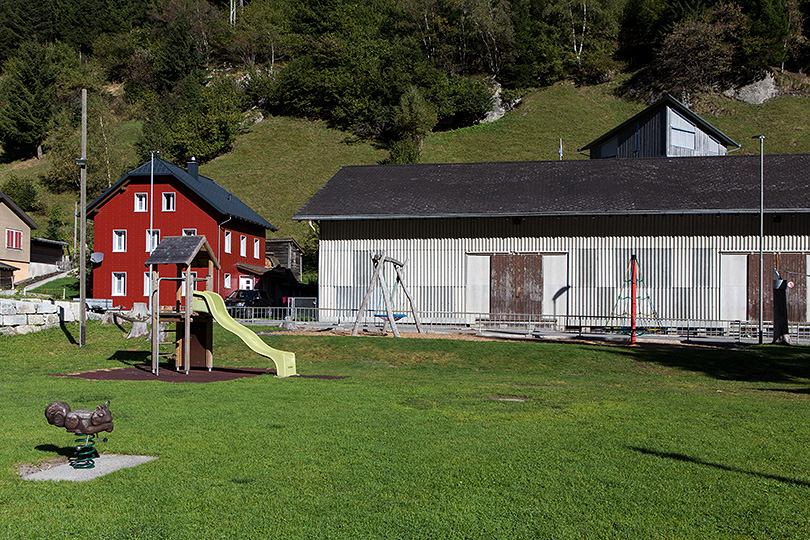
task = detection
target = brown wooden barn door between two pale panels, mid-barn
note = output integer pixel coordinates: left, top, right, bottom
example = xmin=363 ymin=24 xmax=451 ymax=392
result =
xmin=489 ymin=253 xmax=543 ymax=314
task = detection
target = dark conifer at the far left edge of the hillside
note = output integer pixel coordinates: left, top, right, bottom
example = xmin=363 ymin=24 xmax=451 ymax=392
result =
xmin=0 ymin=41 xmax=56 ymax=159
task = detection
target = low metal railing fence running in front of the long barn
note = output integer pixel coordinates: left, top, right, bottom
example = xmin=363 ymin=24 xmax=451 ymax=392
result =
xmin=223 ymin=303 xmax=810 ymax=344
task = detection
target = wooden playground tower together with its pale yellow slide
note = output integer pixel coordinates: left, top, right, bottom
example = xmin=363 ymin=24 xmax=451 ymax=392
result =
xmin=145 ymin=236 xmax=296 ymax=377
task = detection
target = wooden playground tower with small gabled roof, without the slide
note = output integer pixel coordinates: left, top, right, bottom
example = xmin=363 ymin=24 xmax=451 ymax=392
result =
xmin=145 ymin=236 xmax=220 ymax=375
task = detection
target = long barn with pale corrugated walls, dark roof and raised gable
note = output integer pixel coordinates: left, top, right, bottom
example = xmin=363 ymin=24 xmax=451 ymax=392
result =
xmin=294 ymin=99 xmax=810 ymax=332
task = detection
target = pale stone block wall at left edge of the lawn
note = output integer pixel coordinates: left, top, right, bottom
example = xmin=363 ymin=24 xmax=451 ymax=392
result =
xmin=0 ymin=298 xmax=101 ymax=335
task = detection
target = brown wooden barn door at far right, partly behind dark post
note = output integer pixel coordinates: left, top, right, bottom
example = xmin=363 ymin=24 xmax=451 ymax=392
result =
xmin=748 ymin=253 xmax=807 ymax=322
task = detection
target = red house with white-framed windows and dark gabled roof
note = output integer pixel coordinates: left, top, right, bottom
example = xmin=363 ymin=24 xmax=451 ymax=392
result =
xmin=87 ymin=158 xmax=276 ymax=309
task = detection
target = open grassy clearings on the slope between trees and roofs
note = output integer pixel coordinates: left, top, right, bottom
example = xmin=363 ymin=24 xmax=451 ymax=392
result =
xmin=0 ymin=83 xmax=810 ymax=239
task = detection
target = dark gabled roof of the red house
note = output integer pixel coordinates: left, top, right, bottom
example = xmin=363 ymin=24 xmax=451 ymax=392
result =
xmin=87 ymin=158 xmax=277 ymax=231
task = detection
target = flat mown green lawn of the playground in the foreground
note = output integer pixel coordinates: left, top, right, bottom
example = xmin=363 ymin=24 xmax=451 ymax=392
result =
xmin=0 ymin=323 xmax=810 ymax=540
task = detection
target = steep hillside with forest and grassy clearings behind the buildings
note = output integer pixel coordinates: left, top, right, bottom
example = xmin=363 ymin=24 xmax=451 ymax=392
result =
xmin=0 ymin=0 xmax=810 ymax=253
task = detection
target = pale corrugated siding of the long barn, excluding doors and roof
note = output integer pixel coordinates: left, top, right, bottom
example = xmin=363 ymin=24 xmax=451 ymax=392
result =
xmin=319 ymin=215 xmax=810 ymax=320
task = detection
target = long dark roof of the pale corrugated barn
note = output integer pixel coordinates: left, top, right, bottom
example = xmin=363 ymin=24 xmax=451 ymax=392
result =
xmin=293 ymin=154 xmax=810 ymax=220
